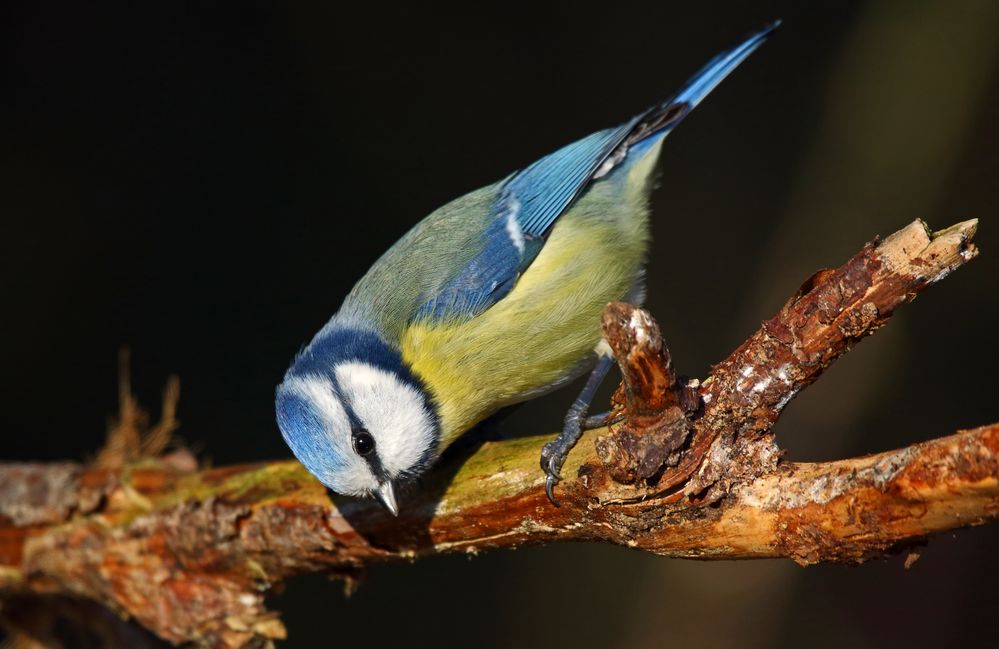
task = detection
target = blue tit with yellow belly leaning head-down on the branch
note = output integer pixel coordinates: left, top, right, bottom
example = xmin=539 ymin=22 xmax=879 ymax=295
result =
xmin=276 ymin=24 xmax=776 ymax=514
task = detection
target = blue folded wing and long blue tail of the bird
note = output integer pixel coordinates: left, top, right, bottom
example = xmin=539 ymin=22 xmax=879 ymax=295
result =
xmin=417 ymin=22 xmax=779 ymax=320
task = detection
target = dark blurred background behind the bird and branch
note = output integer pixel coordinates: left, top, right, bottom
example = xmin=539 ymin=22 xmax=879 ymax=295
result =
xmin=0 ymin=0 xmax=999 ymax=649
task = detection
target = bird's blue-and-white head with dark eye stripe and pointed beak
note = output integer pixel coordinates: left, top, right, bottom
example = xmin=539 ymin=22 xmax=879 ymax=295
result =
xmin=276 ymin=342 xmax=439 ymax=514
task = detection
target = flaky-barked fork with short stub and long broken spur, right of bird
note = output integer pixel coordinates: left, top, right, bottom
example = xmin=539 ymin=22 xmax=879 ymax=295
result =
xmin=596 ymin=221 xmax=978 ymax=502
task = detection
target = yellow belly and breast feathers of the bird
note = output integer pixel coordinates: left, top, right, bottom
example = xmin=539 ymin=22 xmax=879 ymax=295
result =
xmin=402 ymin=200 xmax=648 ymax=449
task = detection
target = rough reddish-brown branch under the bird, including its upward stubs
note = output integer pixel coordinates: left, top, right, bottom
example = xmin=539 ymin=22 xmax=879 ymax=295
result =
xmin=0 ymin=221 xmax=984 ymax=646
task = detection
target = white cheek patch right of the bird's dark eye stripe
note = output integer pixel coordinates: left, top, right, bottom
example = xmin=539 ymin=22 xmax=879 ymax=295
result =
xmin=334 ymin=361 xmax=435 ymax=477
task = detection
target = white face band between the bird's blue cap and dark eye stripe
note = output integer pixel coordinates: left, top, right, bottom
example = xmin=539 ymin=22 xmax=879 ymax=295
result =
xmin=283 ymin=376 xmax=378 ymax=496
